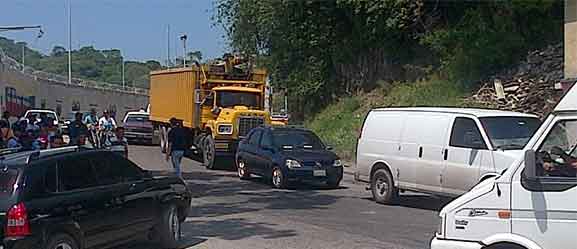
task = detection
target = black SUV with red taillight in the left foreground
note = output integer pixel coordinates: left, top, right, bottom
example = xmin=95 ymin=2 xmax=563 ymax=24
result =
xmin=0 ymin=147 xmax=191 ymax=249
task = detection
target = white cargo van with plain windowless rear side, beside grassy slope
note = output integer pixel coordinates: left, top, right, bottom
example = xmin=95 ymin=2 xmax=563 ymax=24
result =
xmin=355 ymin=108 xmax=540 ymax=203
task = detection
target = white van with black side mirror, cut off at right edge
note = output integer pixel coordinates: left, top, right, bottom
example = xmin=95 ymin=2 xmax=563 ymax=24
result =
xmin=431 ymin=87 xmax=577 ymax=249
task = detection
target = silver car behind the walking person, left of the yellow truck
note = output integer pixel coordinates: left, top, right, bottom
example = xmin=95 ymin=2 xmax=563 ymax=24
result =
xmin=123 ymin=111 xmax=153 ymax=144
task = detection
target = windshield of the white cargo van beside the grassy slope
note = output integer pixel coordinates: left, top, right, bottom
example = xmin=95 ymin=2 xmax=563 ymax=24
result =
xmin=480 ymin=117 xmax=541 ymax=150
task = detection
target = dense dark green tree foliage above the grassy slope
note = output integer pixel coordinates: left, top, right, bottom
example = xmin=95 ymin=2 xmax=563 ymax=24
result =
xmin=214 ymin=0 xmax=563 ymax=118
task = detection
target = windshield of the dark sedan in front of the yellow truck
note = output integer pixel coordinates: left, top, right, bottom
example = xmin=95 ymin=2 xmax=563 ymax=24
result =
xmin=273 ymin=131 xmax=325 ymax=150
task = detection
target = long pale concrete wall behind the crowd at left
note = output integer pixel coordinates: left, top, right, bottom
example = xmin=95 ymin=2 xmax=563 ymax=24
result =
xmin=0 ymin=57 xmax=148 ymax=120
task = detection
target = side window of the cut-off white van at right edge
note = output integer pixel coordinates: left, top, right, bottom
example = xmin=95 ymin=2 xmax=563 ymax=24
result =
xmin=537 ymin=120 xmax=577 ymax=178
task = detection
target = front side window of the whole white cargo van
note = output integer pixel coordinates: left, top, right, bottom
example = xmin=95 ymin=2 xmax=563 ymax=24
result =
xmin=449 ymin=118 xmax=487 ymax=150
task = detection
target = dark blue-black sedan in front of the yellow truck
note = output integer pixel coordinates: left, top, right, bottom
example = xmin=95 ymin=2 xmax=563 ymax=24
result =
xmin=236 ymin=127 xmax=343 ymax=188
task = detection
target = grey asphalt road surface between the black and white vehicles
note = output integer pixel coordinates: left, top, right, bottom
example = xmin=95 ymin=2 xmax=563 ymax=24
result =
xmin=124 ymin=146 xmax=443 ymax=249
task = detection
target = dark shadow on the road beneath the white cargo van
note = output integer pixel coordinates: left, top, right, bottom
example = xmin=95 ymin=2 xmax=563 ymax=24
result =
xmin=362 ymin=194 xmax=453 ymax=212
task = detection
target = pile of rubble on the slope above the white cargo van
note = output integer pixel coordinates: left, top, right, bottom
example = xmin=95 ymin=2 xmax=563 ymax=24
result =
xmin=469 ymin=44 xmax=563 ymax=117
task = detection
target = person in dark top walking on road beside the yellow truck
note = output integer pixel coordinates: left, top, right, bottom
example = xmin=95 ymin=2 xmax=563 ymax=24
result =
xmin=166 ymin=118 xmax=187 ymax=178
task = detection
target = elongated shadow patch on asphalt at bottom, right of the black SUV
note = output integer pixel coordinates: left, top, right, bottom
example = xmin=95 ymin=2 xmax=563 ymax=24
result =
xmin=182 ymin=218 xmax=297 ymax=240
